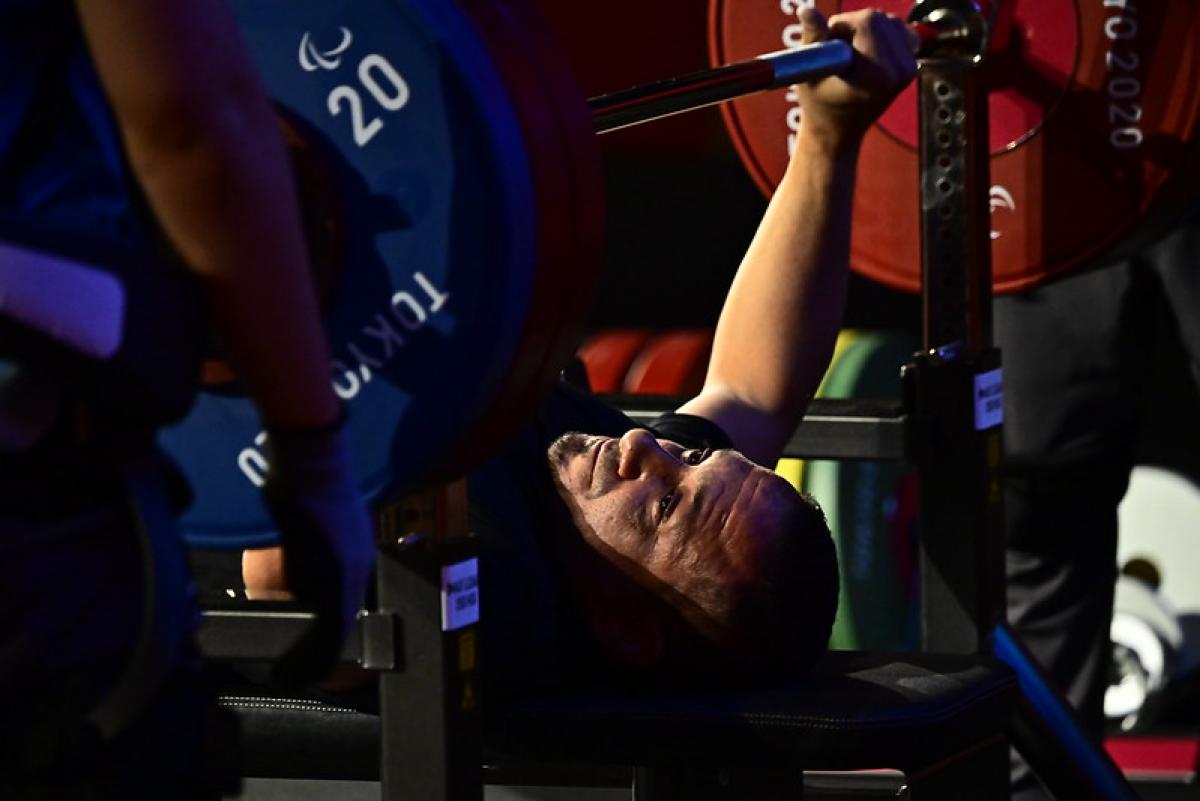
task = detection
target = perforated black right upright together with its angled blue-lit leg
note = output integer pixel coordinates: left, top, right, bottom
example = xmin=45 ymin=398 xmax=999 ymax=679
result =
xmin=904 ymin=0 xmax=1136 ymax=801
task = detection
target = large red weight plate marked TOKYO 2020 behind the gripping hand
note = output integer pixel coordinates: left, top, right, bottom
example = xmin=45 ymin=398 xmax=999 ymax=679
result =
xmin=709 ymin=0 xmax=1200 ymax=293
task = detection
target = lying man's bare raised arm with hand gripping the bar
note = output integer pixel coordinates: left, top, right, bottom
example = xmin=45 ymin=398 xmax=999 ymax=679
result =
xmin=679 ymin=10 xmax=916 ymax=464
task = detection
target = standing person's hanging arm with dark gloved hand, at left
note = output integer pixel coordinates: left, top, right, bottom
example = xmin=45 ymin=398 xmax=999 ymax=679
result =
xmin=76 ymin=0 xmax=374 ymax=682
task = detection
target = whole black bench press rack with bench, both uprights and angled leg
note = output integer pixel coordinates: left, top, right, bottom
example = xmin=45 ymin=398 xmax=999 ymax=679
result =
xmin=200 ymin=2 xmax=1135 ymax=801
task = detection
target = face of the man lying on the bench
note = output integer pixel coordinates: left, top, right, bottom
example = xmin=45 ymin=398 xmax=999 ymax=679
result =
xmin=548 ymin=429 xmax=784 ymax=607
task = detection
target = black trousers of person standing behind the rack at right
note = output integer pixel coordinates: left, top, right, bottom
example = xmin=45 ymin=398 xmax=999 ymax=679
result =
xmin=995 ymin=216 xmax=1200 ymax=801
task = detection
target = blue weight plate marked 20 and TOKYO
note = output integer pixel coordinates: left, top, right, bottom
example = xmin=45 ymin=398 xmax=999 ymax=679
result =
xmin=162 ymin=0 xmax=536 ymax=548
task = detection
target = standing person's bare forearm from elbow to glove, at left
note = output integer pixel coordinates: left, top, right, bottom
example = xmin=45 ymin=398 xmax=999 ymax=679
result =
xmin=131 ymin=112 xmax=337 ymax=428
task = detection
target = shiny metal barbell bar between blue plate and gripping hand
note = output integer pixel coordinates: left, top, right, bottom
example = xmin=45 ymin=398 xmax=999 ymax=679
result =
xmin=588 ymin=40 xmax=854 ymax=133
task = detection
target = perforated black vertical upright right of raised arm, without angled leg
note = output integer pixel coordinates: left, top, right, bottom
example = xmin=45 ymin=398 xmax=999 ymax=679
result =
xmin=904 ymin=4 xmax=1004 ymax=654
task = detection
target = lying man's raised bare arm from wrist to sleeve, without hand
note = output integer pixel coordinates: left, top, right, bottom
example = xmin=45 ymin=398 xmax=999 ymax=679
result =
xmin=682 ymin=128 xmax=858 ymax=462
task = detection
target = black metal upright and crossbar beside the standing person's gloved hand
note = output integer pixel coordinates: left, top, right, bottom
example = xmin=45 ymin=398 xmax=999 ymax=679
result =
xmin=197 ymin=537 xmax=484 ymax=801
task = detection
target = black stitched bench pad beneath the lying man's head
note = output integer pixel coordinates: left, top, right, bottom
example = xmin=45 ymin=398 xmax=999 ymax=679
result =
xmin=222 ymin=651 xmax=1016 ymax=778
